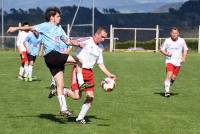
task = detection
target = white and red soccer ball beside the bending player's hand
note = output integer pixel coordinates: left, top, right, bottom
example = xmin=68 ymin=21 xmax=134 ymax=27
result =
xmin=101 ymin=77 xmax=115 ymax=92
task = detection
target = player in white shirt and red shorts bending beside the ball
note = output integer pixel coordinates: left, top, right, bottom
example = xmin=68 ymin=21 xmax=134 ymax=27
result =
xmin=49 ymin=27 xmax=116 ymax=124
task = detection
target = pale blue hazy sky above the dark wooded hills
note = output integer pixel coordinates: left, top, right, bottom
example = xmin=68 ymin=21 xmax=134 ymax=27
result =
xmin=0 ymin=0 xmax=187 ymax=12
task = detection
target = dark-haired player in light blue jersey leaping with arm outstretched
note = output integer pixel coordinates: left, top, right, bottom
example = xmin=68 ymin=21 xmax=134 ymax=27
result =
xmin=7 ymin=7 xmax=85 ymax=117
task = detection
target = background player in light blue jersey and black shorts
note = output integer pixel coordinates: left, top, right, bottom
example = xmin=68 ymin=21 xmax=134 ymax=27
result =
xmin=24 ymin=31 xmax=42 ymax=81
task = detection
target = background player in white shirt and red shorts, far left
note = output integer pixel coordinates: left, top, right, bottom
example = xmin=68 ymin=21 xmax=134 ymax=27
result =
xmin=17 ymin=22 xmax=30 ymax=80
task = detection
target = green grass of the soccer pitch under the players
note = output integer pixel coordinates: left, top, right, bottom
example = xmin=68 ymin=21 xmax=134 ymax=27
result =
xmin=0 ymin=51 xmax=200 ymax=134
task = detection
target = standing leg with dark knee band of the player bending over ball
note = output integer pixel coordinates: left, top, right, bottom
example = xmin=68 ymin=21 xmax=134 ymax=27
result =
xmin=76 ymin=91 xmax=94 ymax=124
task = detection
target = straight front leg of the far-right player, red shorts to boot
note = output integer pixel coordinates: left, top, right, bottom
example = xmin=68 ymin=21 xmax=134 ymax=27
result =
xmin=164 ymin=63 xmax=174 ymax=97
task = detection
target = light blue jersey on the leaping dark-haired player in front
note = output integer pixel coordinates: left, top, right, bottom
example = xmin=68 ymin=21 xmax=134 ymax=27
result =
xmin=34 ymin=22 xmax=67 ymax=55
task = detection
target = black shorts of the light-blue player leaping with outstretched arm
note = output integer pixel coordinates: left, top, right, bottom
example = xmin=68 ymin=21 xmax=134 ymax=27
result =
xmin=44 ymin=51 xmax=69 ymax=76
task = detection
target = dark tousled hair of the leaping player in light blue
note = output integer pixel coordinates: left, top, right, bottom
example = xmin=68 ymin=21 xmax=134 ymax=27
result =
xmin=45 ymin=7 xmax=61 ymax=22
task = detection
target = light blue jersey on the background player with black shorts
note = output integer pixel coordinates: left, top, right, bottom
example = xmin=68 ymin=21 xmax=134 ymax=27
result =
xmin=25 ymin=33 xmax=42 ymax=56
